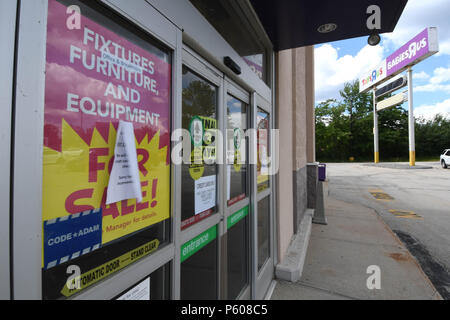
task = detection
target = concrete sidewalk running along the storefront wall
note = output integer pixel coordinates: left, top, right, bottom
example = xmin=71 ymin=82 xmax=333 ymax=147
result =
xmin=271 ymin=191 xmax=441 ymax=300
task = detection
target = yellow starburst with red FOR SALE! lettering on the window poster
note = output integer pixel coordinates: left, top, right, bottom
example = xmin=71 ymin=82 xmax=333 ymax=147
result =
xmin=42 ymin=120 xmax=170 ymax=244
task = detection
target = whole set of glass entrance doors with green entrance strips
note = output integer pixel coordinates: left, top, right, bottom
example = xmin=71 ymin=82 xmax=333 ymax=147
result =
xmin=179 ymin=48 xmax=274 ymax=300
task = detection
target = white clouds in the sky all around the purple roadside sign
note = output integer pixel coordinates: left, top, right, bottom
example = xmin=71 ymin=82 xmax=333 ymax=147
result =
xmin=315 ymin=0 xmax=450 ymax=102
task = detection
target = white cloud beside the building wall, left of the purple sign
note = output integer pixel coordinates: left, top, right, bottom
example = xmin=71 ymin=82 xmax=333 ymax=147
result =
xmin=314 ymin=44 xmax=383 ymax=102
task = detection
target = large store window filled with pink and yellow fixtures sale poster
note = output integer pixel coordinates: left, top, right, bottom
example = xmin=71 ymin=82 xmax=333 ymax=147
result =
xmin=42 ymin=0 xmax=172 ymax=299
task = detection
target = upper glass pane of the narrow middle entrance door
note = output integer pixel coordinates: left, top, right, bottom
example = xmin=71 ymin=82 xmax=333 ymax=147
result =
xmin=227 ymin=95 xmax=248 ymax=206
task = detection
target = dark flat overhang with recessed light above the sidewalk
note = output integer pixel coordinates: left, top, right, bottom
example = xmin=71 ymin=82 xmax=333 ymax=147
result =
xmin=250 ymin=0 xmax=408 ymax=51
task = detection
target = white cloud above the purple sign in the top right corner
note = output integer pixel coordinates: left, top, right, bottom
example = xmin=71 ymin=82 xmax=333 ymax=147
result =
xmin=382 ymin=0 xmax=450 ymax=55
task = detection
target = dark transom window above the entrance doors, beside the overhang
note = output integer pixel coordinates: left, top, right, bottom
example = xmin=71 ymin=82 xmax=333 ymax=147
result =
xmin=190 ymin=0 xmax=270 ymax=85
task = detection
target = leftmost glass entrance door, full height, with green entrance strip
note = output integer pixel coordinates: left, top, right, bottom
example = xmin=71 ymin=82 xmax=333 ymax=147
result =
xmin=180 ymin=57 xmax=221 ymax=300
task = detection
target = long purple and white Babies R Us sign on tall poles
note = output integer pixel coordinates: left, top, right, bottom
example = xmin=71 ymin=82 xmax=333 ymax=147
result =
xmin=359 ymin=27 xmax=439 ymax=93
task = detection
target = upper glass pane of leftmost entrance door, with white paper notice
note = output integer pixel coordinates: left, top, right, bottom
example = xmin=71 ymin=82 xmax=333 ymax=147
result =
xmin=181 ymin=66 xmax=218 ymax=229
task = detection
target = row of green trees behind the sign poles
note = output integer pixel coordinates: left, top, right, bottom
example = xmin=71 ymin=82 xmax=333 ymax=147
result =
xmin=316 ymin=81 xmax=450 ymax=161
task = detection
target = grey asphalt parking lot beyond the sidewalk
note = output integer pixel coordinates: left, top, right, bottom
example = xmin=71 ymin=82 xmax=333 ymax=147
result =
xmin=326 ymin=162 xmax=450 ymax=299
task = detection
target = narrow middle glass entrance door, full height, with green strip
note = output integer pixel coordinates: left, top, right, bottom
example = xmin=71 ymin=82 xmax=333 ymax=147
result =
xmin=225 ymin=83 xmax=250 ymax=299
